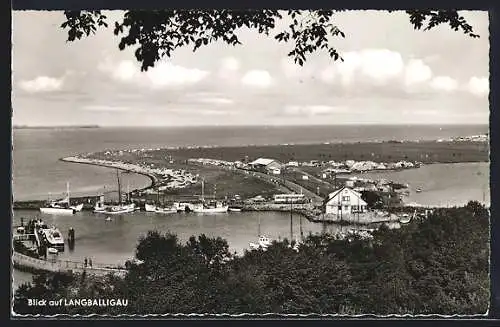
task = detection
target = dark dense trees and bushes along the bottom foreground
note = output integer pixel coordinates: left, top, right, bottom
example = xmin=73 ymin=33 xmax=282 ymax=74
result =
xmin=14 ymin=202 xmax=489 ymax=314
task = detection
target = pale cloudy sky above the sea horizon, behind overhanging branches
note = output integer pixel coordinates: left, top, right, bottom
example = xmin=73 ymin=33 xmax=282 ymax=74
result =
xmin=12 ymin=11 xmax=489 ymax=126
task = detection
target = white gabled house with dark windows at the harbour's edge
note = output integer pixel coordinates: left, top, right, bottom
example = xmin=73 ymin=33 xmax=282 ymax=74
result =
xmin=324 ymin=187 xmax=367 ymax=216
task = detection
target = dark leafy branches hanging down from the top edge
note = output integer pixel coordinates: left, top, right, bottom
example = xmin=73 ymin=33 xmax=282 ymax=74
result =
xmin=61 ymin=10 xmax=479 ymax=71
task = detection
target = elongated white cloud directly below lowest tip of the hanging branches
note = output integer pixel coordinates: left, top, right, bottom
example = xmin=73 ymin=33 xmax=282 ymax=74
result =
xmin=98 ymin=60 xmax=209 ymax=89
